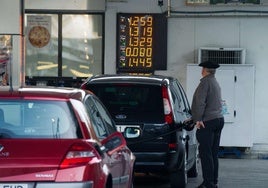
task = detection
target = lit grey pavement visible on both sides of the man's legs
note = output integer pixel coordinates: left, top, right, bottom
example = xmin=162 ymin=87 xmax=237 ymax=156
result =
xmin=187 ymin=158 xmax=268 ymax=188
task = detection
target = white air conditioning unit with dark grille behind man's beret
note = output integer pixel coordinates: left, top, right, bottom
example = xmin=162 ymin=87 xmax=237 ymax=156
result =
xmin=198 ymin=47 xmax=246 ymax=64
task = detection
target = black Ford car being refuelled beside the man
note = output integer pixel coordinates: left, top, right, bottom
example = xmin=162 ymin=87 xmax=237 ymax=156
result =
xmin=81 ymin=75 xmax=197 ymax=188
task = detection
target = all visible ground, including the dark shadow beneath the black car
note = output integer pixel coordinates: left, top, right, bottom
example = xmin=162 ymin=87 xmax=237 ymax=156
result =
xmin=134 ymin=155 xmax=268 ymax=188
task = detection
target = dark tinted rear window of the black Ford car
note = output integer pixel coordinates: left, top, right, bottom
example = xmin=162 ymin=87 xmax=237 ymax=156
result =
xmin=89 ymin=83 xmax=164 ymax=123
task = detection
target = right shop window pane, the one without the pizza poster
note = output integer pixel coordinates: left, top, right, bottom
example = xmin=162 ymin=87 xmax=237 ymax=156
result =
xmin=62 ymin=15 xmax=102 ymax=77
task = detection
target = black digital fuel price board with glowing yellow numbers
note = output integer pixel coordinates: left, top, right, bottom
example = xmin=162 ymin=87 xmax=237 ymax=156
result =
xmin=116 ymin=13 xmax=167 ymax=73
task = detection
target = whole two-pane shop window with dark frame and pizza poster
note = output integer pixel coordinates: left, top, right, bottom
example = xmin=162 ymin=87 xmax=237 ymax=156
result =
xmin=25 ymin=13 xmax=103 ymax=86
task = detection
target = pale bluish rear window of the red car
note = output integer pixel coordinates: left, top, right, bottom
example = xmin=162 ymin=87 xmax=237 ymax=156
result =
xmin=0 ymin=99 xmax=78 ymax=139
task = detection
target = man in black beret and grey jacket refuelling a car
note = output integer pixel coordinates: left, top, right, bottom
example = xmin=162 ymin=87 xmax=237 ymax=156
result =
xmin=191 ymin=61 xmax=224 ymax=188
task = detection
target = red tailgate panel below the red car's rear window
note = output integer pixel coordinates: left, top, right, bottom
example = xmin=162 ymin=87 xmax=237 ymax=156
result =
xmin=0 ymin=139 xmax=77 ymax=181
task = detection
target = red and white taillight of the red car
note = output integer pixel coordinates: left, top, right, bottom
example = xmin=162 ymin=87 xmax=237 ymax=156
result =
xmin=60 ymin=144 xmax=97 ymax=168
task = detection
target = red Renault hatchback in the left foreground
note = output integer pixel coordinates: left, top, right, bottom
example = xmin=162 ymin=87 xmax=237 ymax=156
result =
xmin=0 ymin=87 xmax=135 ymax=188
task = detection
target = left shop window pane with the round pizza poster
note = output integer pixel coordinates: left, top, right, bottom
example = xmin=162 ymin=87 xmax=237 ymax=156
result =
xmin=25 ymin=14 xmax=59 ymax=77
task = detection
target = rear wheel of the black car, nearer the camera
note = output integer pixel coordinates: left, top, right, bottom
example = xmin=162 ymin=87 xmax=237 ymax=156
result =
xmin=170 ymin=153 xmax=187 ymax=188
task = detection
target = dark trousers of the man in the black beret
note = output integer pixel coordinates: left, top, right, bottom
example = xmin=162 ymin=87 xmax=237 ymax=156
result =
xmin=196 ymin=118 xmax=224 ymax=188
